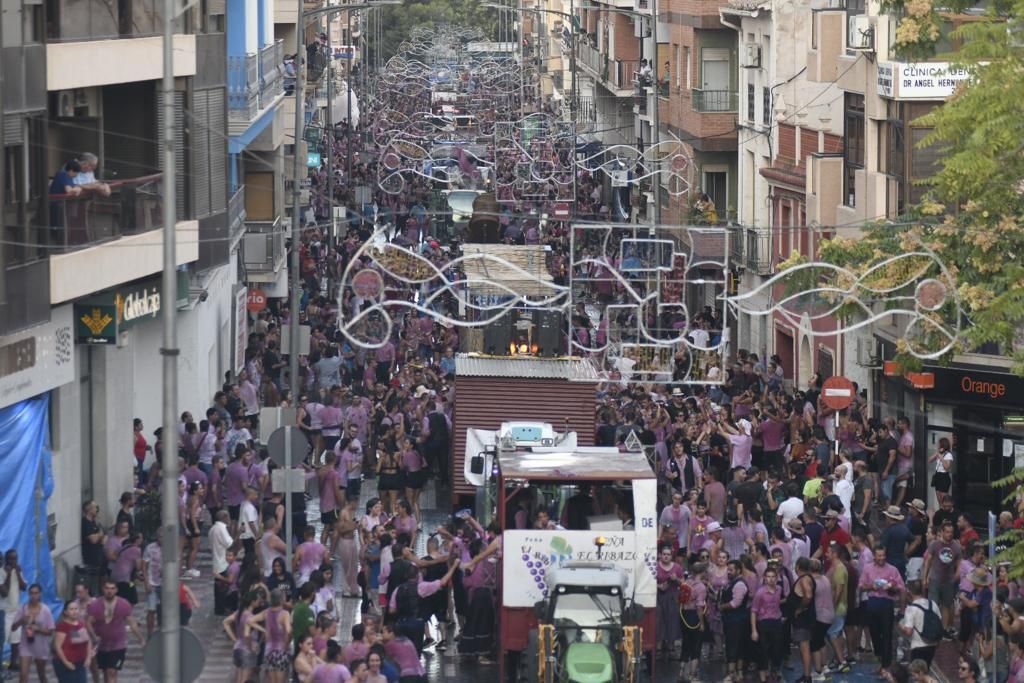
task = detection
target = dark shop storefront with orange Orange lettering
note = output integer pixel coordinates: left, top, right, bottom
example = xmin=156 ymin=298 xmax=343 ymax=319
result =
xmin=876 ymin=348 xmax=1024 ymax=526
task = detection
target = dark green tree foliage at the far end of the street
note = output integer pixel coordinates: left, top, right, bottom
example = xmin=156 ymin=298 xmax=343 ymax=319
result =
xmin=370 ymin=0 xmax=498 ymax=63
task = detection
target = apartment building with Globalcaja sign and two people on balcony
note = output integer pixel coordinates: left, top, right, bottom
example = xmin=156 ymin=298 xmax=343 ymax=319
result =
xmin=0 ymin=0 xmax=244 ymax=588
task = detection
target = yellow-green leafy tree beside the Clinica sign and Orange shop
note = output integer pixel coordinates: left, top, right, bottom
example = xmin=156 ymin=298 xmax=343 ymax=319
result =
xmin=782 ymin=0 xmax=1024 ymax=577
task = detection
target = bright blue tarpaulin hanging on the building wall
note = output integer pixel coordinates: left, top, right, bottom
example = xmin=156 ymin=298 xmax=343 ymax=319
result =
xmin=0 ymin=394 xmax=62 ymax=620
